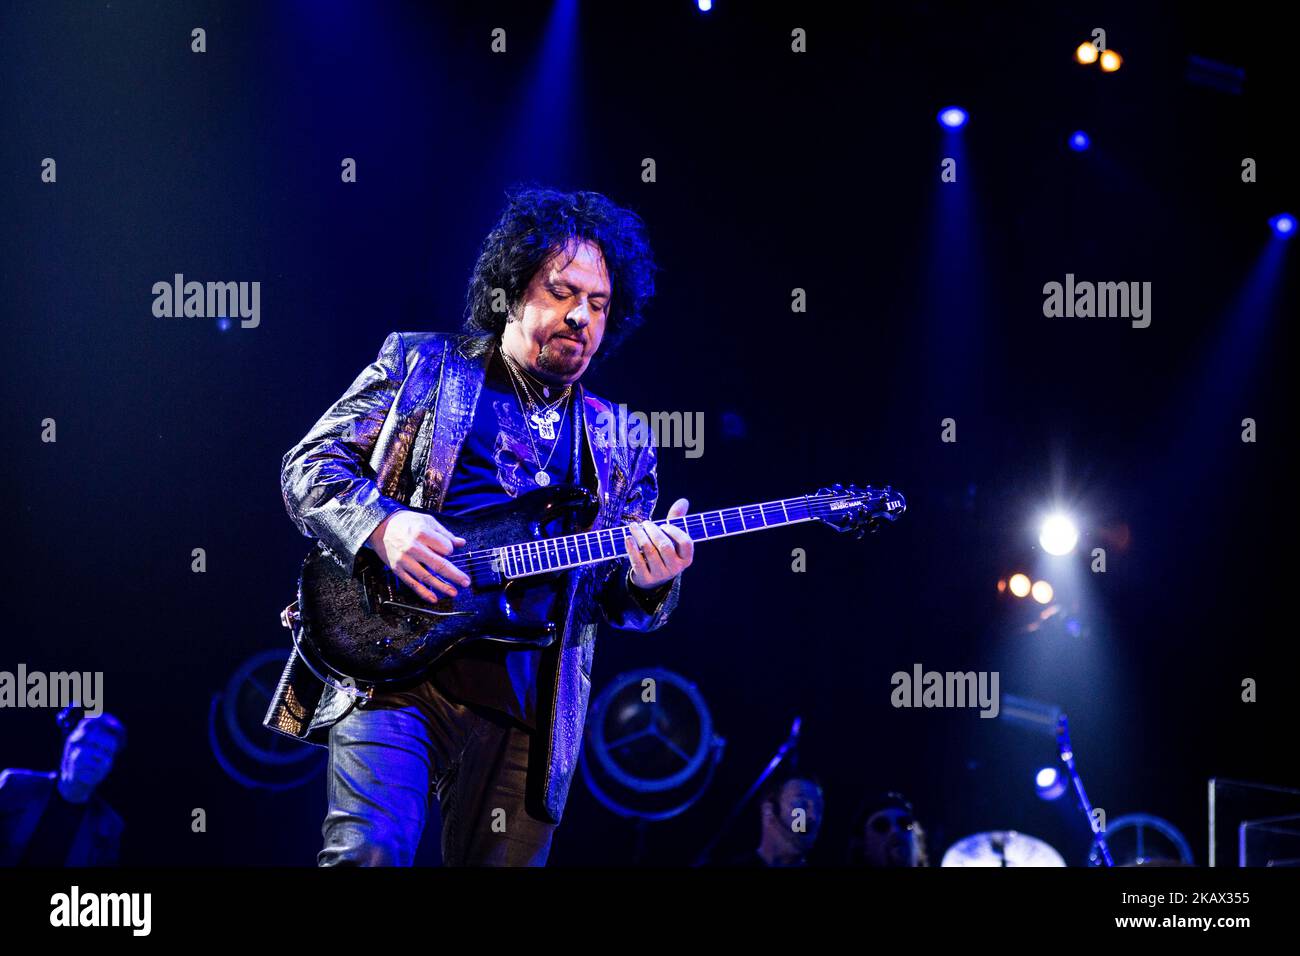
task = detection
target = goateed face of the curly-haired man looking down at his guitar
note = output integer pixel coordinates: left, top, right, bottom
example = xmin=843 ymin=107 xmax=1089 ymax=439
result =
xmin=502 ymin=242 xmax=611 ymax=385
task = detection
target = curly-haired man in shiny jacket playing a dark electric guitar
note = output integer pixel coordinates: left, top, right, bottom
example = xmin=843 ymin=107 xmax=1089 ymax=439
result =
xmin=267 ymin=190 xmax=693 ymax=865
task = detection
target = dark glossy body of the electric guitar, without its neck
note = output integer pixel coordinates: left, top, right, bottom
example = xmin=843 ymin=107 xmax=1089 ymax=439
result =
xmin=296 ymin=485 xmax=597 ymax=687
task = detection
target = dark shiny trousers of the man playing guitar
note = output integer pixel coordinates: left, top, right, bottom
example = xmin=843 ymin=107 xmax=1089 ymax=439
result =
xmin=317 ymin=682 xmax=555 ymax=866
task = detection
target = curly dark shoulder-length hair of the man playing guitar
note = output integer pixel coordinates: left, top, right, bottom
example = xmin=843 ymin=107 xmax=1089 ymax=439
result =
xmin=465 ymin=186 xmax=659 ymax=354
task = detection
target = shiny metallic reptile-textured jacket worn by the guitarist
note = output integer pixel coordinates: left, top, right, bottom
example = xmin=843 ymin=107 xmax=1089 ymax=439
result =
xmin=264 ymin=332 xmax=681 ymax=823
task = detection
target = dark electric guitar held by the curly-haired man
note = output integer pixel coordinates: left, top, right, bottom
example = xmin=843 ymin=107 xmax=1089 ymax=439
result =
xmin=281 ymin=485 xmax=907 ymax=696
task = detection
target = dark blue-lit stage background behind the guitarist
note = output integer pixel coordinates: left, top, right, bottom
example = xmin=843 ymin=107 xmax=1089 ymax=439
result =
xmin=0 ymin=0 xmax=1300 ymax=864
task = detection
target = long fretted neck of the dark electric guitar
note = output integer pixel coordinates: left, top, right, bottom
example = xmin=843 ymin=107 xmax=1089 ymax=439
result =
xmin=483 ymin=494 xmax=832 ymax=578
